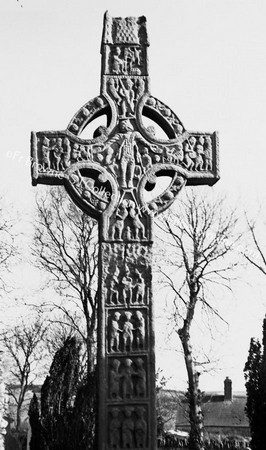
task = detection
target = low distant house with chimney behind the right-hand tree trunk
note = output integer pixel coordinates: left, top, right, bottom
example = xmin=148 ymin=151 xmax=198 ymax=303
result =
xmin=160 ymin=377 xmax=250 ymax=437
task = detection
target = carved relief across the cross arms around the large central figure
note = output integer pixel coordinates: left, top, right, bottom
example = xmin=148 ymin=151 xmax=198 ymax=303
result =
xmin=35 ymin=123 xmax=216 ymax=195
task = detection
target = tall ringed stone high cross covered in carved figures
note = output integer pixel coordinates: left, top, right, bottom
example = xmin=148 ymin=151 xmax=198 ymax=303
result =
xmin=31 ymin=13 xmax=219 ymax=450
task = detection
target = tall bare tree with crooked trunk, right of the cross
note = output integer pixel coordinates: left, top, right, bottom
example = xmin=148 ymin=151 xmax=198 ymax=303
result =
xmin=155 ymin=190 xmax=239 ymax=450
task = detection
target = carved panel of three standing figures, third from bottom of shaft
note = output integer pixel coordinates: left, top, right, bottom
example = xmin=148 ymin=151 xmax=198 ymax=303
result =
xmin=107 ymin=310 xmax=147 ymax=353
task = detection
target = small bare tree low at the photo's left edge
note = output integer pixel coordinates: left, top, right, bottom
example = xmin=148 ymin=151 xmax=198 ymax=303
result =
xmin=0 ymin=319 xmax=47 ymax=430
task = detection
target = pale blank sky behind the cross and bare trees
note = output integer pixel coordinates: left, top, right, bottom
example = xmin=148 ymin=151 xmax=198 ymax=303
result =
xmin=0 ymin=0 xmax=266 ymax=390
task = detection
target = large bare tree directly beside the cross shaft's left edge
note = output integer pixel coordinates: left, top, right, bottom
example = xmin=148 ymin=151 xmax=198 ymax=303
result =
xmin=33 ymin=188 xmax=98 ymax=371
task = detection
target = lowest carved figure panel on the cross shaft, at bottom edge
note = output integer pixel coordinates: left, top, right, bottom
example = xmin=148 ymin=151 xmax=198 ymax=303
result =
xmin=109 ymin=405 xmax=148 ymax=449
